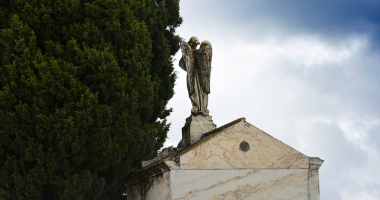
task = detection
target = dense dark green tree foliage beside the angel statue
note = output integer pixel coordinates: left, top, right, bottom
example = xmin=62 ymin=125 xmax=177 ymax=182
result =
xmin=0 ymin=0 xmax=182 ymax=199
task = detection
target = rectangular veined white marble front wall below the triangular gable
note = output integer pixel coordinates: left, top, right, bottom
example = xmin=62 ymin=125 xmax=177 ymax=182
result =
xmin=170 ymin=169 xmax=319 ymax=200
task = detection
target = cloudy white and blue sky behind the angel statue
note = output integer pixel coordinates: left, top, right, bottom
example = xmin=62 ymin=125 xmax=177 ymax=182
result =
xmin=165 ymin=0 xmax=380 ymax=200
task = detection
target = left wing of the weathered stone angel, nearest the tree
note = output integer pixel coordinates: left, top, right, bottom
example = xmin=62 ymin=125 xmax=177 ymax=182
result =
xmin=180 ymin=39 xmax=194 ymax=95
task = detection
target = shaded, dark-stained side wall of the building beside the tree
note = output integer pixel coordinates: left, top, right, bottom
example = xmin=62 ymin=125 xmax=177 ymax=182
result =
xmin=127 ymin=171 xmax=170 ymax=200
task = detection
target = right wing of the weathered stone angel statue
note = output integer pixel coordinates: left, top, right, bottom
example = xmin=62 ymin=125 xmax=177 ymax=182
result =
xmin=199 ymin=40 xmax=212 ymax=94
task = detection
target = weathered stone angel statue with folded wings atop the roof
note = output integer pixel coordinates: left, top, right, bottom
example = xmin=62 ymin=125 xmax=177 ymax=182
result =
xmin=179 ymin=36 xmax=212 ymax=116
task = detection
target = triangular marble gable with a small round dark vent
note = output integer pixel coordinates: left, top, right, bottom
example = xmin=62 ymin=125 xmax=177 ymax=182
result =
xmin=180 ymin=121 xmax=309 ymax=169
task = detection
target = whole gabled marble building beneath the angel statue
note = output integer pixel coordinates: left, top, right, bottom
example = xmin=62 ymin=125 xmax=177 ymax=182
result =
xmin=124 ymin=118 xmax=323 ymax=200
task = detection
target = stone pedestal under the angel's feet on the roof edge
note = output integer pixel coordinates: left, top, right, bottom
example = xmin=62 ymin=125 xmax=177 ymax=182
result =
xmin=177 ymin=115 xmax=216 ymax=148
